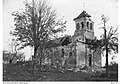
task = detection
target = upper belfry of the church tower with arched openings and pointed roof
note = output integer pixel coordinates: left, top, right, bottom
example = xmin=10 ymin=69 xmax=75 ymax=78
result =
xmin=73 ymin=11 xmax=94 ymax=41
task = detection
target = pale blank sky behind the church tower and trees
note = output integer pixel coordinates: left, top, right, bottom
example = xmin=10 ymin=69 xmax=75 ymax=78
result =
xmin=3 ymin=0 xmax=118 ymax=65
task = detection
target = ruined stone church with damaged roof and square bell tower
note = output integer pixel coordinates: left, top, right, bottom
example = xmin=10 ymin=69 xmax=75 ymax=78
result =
xmin=39 ymin=11 xmax=102 ymax=69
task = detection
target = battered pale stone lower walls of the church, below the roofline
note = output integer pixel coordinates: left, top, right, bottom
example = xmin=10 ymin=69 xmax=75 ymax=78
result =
xmin=38 ymin=42 xmax=101 ymax=68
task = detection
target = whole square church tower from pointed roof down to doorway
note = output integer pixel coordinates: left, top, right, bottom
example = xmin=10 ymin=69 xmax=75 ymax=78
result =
xmin=73 ymin=10 xmax=95 ymax=67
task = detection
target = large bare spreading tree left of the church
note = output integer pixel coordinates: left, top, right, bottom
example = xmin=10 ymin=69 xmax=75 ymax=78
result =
xmin=11 ymin=0 xmax=66 ymax=72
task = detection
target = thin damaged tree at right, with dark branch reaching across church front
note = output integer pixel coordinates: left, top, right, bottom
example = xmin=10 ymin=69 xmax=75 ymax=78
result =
xmin=82 ymin=15 xmax=118 ymax=77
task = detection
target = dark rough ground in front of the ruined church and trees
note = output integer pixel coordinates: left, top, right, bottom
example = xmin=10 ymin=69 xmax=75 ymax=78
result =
xmin=3 ymin=62 xmax=118 ymax=81
